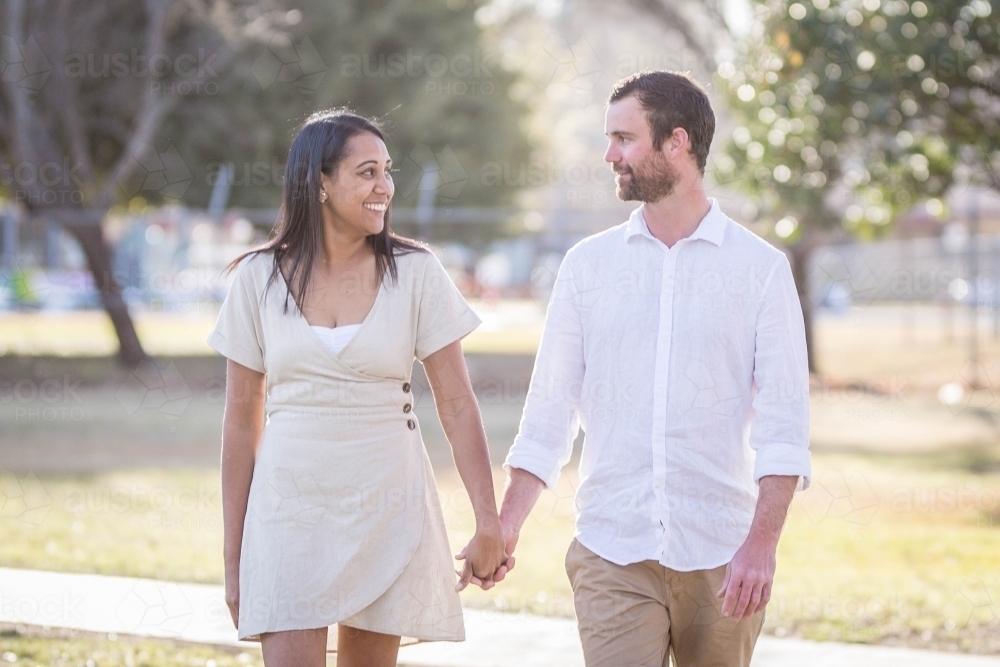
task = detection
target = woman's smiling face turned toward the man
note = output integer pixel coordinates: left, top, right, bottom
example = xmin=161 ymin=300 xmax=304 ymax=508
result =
xmin=320 ymin=132 xmax=395 ymax=236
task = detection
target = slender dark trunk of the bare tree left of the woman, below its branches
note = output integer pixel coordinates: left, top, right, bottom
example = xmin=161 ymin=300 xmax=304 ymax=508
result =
xmin=65 ymin=216 xmax=149 ymax=368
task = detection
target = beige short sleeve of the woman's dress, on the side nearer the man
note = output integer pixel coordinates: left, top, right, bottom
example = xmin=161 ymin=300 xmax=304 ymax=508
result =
xmin=414 ymin=252 xmax=482 ymax=361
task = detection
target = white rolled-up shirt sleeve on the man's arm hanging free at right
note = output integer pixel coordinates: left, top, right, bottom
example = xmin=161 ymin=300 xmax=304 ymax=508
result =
xmin=750 ymin=256 xmax=812 ymax=491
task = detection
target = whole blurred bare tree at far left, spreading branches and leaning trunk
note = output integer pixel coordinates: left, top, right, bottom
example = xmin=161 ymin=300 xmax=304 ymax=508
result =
xmin=0 ymin=0 xmax=284 ymax=366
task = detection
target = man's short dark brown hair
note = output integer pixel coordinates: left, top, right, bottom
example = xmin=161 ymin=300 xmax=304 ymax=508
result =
xmin=608 ymin=70 xmax=715 ymax=175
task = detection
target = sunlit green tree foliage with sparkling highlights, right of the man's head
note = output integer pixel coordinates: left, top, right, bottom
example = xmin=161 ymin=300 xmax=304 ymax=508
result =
xmin=719 ymin=0 xmax=1000 ymax=240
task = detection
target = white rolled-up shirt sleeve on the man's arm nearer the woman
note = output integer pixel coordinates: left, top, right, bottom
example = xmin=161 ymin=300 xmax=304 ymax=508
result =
xmin=503 ymin=254 xmax=584 ymax=488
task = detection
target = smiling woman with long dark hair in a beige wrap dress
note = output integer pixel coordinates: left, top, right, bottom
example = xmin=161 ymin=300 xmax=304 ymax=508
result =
xmin=208 ymin=110 xmax=505 ymax=667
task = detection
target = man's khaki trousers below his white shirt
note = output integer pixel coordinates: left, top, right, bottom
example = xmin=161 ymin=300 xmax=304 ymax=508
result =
xmin=566 ymin=539 xmax=764 ymax=667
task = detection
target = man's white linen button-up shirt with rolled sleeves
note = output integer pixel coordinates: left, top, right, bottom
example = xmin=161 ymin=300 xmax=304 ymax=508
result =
xmin=504 ymin=199 xmax=810 ymax=571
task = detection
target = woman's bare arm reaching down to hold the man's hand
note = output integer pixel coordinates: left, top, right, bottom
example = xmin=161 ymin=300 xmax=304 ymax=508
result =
xmin=424 ymin=341 xmax=505 ymax=590
